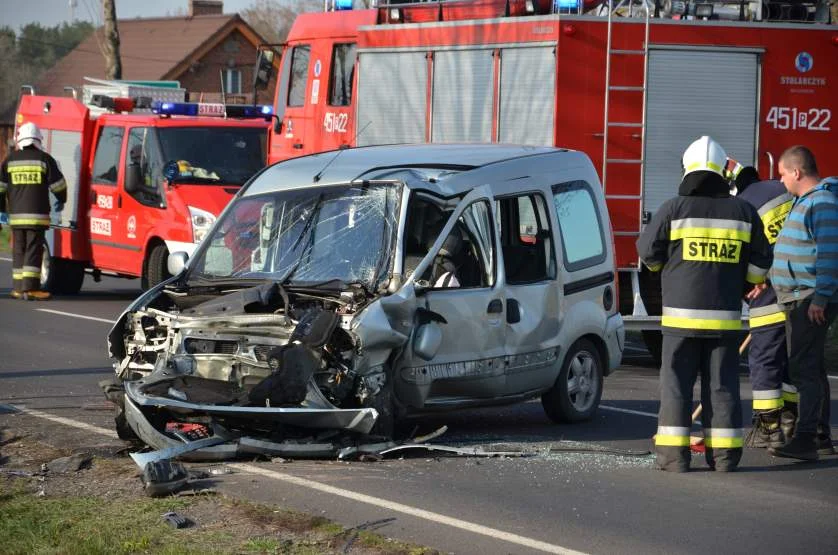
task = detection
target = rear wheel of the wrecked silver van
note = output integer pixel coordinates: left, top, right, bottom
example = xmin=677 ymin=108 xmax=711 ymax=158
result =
xmin=541 ymin=339 xmax=604 ymax=423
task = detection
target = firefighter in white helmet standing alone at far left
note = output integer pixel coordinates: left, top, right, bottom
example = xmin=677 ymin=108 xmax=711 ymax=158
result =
xmin=0 ymin=122 xmax=67 ymax=300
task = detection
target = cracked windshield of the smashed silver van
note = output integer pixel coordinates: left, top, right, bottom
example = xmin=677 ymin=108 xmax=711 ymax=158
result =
xmin=190 ymin=183 xmax=401 ymax=288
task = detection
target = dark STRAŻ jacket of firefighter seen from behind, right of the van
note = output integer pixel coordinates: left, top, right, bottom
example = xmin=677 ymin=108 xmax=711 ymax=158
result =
xmin=637 ymin=171 xmax=771 ymax=336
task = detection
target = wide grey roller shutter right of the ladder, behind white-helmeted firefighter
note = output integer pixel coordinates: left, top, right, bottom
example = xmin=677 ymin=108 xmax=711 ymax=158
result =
xmin=643 ymin=48 xmax=759 ymax=213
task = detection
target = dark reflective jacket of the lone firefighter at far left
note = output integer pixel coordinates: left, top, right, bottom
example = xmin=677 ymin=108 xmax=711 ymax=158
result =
xmin=0 ymin=146 xmax=67 ymax=227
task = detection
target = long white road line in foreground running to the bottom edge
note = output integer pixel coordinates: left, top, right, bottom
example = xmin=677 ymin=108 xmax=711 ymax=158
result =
xmin=230 ymin=463 xmax=582 ymax=555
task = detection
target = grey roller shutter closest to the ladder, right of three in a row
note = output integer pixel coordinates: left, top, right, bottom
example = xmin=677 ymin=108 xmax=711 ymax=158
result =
xmin=498 ymin=46 xmax=556 ymax=146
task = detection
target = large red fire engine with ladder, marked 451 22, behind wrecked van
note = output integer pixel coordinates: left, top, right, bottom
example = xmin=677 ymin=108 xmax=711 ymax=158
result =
xmin=260 ymin=0 xmax=838 ymax=356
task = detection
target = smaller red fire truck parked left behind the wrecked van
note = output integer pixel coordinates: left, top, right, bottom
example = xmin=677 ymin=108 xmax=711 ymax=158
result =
xmin=17 ymin=89 xmax=272 ymax=294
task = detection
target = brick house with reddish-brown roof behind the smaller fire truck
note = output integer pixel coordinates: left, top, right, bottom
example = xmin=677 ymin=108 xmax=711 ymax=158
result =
xmin=35 ymin=0 xmax=273 ymax=103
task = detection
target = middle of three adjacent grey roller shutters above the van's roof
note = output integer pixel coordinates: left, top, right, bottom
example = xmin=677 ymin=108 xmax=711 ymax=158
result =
xmin=431 ymin=49 xmax=493 ymax=143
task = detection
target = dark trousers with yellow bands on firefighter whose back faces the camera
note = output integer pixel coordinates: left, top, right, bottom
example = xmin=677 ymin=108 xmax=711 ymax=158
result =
xmin=655 ymin=332 xmax=743 ymax=472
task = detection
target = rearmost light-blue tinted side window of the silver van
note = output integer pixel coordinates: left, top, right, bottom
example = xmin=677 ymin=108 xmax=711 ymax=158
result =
xmin=553 ymin=181 xmax=606 ymax=271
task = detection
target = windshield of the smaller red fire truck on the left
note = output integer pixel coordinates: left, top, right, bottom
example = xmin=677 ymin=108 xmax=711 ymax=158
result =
xmin=158 ymin=126 xmax=267 ymax=185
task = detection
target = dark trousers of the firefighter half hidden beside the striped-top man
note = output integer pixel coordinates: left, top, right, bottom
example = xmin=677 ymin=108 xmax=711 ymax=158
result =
xmin=748 ymin=323 xmax=797 ymax=411
